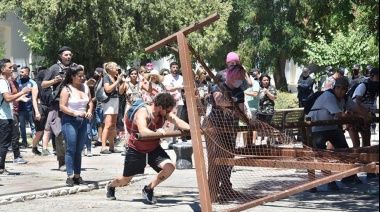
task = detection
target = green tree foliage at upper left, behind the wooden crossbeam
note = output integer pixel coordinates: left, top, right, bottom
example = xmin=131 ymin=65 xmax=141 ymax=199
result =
xmin=0 ymin=0 xmax=231 ymax=71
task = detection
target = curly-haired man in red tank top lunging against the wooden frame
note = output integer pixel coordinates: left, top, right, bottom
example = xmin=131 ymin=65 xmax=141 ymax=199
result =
xmin=105 ymin=93 xmax=190 ymax=204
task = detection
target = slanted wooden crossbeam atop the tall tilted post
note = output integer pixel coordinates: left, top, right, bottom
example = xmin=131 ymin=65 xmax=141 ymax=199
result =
xmin=145 ymin=13 xmax=220 ymax=53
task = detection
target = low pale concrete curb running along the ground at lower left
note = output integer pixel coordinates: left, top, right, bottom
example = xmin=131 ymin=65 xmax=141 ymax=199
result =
xmin=0 ymin=176 xmax=147 ymax=205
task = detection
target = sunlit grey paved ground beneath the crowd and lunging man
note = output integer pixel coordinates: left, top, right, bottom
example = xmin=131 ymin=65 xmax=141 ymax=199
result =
xmin=0 ymin=133 xmax=379 ymax=212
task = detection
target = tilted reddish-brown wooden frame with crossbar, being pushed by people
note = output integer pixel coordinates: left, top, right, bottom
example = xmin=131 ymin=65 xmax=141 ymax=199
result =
xmin=144 ymin=14 xmax=379 ymax=212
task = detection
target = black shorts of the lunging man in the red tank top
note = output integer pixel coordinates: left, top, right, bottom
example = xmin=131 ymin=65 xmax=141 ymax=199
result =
xmin=123 ymin=146 xmax=171 ymax=177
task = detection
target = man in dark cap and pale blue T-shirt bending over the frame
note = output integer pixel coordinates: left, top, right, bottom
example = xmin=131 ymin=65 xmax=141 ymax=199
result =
xmin=308 ymin=77 xmax=371 ymax=190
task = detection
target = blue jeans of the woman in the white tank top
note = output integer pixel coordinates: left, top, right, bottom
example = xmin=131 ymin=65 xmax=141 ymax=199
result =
xmin=62 ymin=114 xmax=87 ymax=176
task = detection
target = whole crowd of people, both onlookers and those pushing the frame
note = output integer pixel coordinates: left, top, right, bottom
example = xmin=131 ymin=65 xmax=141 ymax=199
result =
xmin=0 ymin=47 xmax=379 ymax=203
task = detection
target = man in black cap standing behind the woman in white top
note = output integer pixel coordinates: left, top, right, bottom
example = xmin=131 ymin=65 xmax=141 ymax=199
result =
xmin=41 ymin=46 xmax=73 ymax=171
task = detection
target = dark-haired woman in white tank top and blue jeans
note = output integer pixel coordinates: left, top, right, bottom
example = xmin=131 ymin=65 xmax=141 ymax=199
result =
xmin=59 ymin=65 xmax=93 ymax=187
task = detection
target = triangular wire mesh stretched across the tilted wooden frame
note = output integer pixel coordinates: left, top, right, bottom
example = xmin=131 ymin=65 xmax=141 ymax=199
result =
xmin=197 ymin=94 xmax=374 ymax=211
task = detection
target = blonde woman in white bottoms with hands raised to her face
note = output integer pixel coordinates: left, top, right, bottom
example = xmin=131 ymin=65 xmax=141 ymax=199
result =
xmin=100 ymin=62 xmax=125 ymax=154
